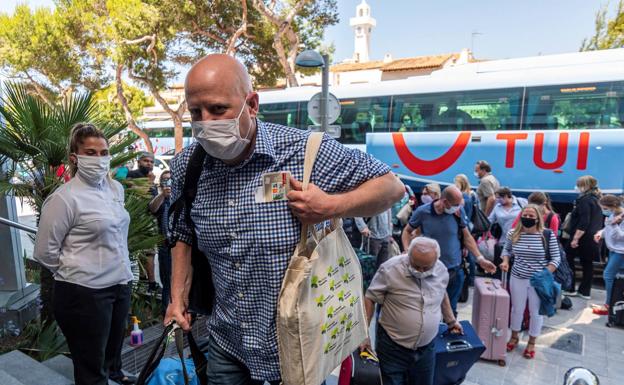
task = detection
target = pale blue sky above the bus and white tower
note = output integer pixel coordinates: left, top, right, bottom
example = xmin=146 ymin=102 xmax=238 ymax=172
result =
xmin=0 ymin=0 xmax=616 ymax=62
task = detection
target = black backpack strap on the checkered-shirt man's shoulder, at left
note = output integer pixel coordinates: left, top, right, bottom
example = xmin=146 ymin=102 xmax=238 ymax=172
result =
xmin=169 ymin=145 xmax=206 ymax=244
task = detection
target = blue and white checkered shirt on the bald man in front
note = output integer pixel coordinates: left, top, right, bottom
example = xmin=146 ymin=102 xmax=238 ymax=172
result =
xmin=172 ymin=121 xmax=390 ymax=381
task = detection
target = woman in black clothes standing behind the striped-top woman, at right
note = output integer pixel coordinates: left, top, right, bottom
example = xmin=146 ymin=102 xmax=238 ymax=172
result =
xmin=564 ymin=175 xmax=604 ymax=299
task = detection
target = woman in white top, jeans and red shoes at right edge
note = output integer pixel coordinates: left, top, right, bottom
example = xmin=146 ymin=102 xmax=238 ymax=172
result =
xmin=593 ymin=195 xmax=624 ymax=315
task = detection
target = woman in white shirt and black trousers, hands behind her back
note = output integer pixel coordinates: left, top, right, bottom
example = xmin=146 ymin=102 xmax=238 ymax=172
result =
xmin=33 ymin=123 xmax=132 ymax=385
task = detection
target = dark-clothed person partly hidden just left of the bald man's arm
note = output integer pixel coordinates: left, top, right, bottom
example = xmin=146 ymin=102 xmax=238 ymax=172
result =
xmin=147 ymin=170 xmax=171 ymax=314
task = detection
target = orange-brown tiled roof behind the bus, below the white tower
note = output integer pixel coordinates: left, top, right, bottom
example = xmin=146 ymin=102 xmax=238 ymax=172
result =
xmin=330 ymin=53 xmax=459 ymax=72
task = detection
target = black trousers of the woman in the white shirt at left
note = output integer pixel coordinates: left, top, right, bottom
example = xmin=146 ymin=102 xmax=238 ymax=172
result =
xmin=54 ymin=281 xmax=130 ymax=385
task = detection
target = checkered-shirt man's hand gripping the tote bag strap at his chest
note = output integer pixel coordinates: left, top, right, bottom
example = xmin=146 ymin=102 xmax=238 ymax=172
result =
xmin=286 ymin=176 xmax=340 ymax=224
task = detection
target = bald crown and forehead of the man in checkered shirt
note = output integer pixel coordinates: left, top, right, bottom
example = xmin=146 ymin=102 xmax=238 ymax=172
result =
xmin=184 ymin=54 xmax=252 ymax=97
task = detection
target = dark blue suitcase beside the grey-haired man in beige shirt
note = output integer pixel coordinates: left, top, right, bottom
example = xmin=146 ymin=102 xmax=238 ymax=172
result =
xmin=433 ymin=321 xmax=485 ymax=385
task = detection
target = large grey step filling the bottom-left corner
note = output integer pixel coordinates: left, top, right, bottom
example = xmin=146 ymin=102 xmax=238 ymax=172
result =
xmin=0 ymin=350 xmax=73 ymax=385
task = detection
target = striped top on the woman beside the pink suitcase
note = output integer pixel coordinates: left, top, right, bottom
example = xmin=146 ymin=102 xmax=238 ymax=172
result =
xmin=502 ymin=230 xmax=561 ymax=279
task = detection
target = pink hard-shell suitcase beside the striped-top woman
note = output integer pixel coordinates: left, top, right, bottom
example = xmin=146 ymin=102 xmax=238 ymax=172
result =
xmin=472 ymin=273 xmax=509 ymax=366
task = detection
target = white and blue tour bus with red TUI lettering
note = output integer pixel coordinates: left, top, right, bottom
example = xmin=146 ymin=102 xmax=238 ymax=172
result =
xmin=260 ymin=49 xmax=624 ymax=203
